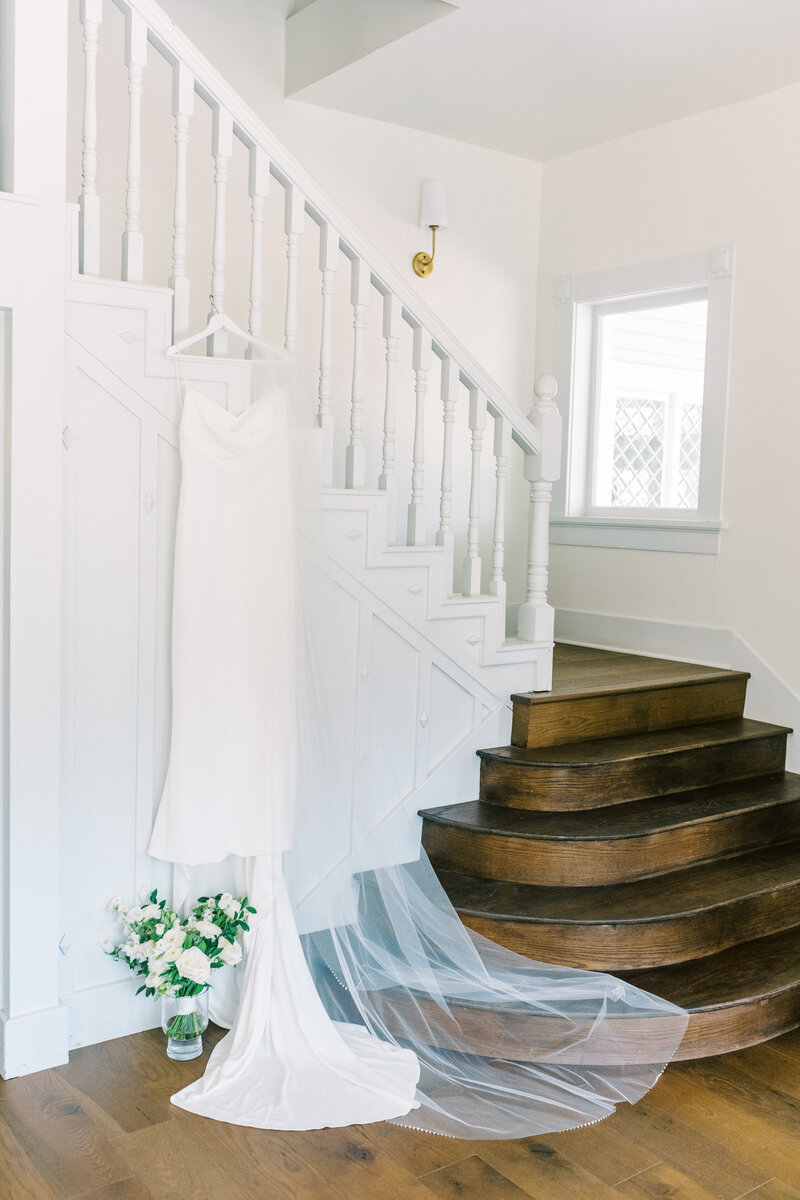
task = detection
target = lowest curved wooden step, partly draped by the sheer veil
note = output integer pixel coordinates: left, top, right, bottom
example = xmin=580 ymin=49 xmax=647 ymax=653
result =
xmin=374 ymin=928 xmax=800 ymax=1064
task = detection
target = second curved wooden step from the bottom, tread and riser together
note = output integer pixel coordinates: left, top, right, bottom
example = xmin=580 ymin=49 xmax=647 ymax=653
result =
xmin=438 ymin=840 xmax=800 ymax=971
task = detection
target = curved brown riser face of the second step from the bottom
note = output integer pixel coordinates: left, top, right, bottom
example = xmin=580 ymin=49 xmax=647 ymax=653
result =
xmin=459 ymin=870 xmax=800 ymax=972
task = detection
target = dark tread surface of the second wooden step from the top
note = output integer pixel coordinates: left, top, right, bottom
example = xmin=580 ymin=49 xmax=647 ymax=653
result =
xmin=477 ymin=718 xmax=792 ymax=767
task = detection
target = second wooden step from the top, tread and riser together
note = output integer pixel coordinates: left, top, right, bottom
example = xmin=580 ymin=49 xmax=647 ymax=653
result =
xmin=477 ymin=720 xmax=792 ymax=811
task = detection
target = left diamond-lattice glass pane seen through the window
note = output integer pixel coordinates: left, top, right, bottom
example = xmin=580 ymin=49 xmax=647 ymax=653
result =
xmin=612 ymin=396 xmax=664 ymax=509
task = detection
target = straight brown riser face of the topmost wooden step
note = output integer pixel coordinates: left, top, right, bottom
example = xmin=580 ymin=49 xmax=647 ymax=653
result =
xmin=511 ymin=676 xmax=747 ymax=749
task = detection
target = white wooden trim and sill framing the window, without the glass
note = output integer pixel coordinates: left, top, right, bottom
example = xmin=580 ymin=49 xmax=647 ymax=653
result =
xmin=551 ymin=246 xmax=734 ymax=554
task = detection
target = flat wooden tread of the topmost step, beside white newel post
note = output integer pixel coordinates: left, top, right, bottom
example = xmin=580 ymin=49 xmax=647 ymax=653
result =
xmin=520 ymin=643 xmax=750 ymax=704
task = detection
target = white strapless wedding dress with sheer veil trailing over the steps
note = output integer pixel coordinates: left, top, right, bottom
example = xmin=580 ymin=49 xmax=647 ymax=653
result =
xmin=150 ymin=366 xmax=687 ymax=1138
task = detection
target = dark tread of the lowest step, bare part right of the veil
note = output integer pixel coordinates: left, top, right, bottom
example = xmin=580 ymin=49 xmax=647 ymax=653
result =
xmin=620 ymin=925 xmax=800 ymax=1013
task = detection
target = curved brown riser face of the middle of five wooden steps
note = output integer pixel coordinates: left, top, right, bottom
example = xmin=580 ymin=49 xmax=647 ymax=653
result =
xmin=422 ymin=802 xmax=800 ymax=887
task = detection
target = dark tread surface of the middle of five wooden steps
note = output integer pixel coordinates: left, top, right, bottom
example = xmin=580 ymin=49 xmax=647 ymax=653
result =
xmin=420 ymin=773 xmax=800 ymax=842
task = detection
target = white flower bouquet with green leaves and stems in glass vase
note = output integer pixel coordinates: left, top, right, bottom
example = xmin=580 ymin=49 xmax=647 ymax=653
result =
xmin=101 ymin=889 xmax=255 ymax=1038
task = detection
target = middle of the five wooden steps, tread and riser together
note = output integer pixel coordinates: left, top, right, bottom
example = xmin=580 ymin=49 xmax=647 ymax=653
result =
xmin=421 ymin=774 xmax=800 ymax=887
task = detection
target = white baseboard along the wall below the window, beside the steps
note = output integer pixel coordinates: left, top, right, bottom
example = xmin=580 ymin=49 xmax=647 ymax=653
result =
xmin=555 ymin=608 xmax=800 ymax=772
